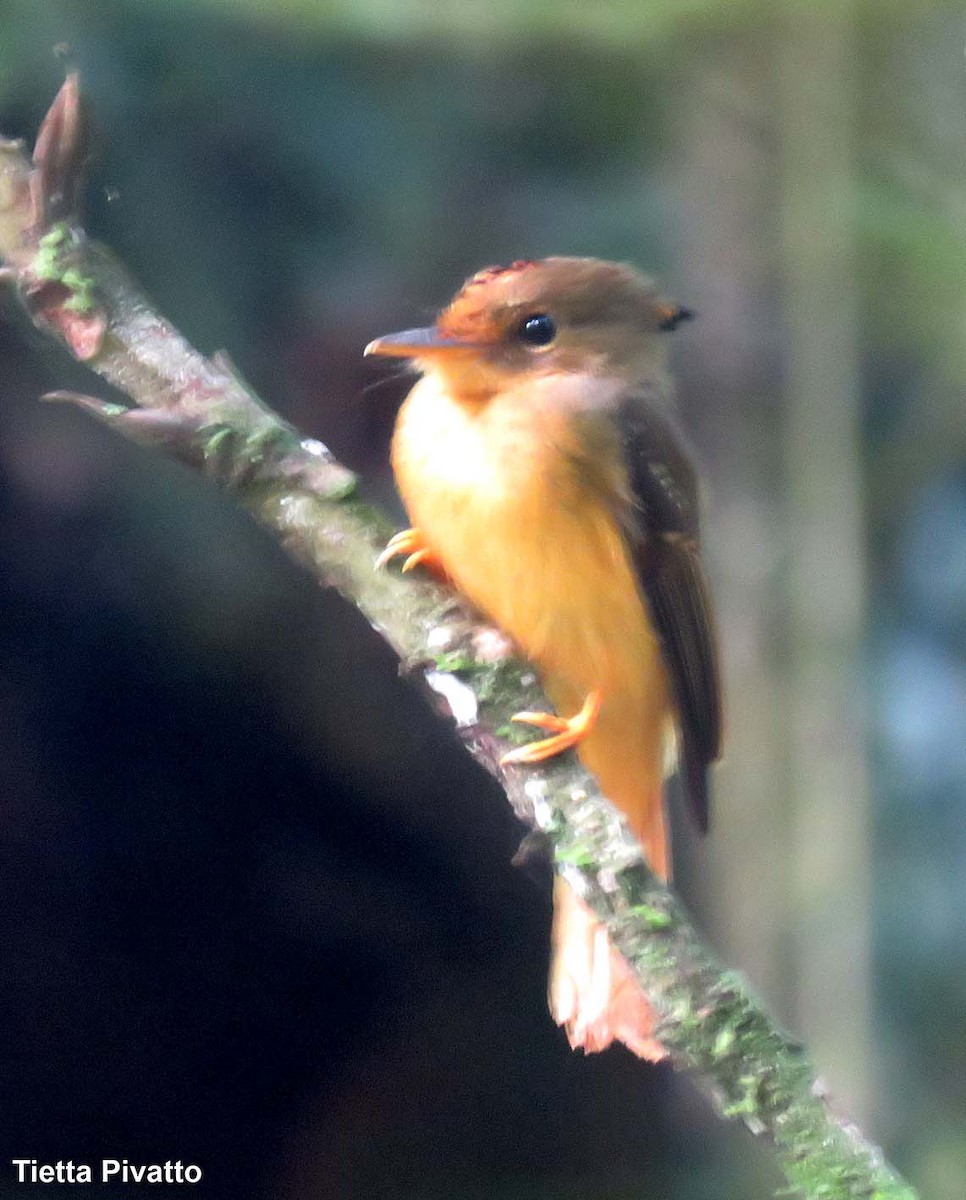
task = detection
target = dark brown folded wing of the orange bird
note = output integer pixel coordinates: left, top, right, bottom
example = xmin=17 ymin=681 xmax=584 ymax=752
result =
xmin=618 ymin=392 xmax=721 ymax=832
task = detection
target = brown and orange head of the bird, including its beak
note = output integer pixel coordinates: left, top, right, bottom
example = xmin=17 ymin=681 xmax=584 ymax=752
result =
xmin=365 ymin=258 xmax=692 ymax=401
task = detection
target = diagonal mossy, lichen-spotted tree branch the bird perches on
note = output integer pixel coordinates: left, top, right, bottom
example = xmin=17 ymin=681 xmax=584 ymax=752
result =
xmin=0 ymin=76 xmax=916 ymax=1200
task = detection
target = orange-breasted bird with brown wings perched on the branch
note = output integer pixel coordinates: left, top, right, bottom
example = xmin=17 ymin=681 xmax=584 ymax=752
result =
xmin=366 ymin=258 xmax=721 ymax=1058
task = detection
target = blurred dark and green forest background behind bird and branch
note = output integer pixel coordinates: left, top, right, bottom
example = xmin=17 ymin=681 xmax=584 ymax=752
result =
xmin=0 ymin=0 xmax=966 ymax=1200
